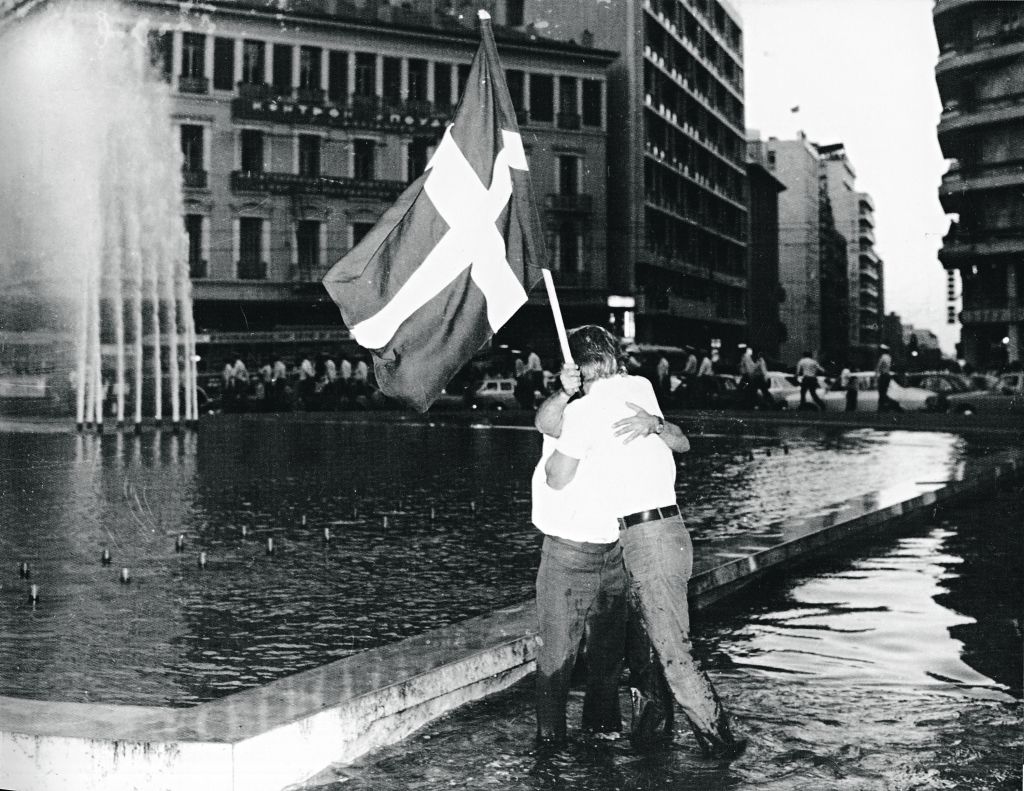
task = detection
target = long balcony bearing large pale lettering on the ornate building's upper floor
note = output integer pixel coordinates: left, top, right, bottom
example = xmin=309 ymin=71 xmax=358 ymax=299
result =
xmin=231 ymin=94 xmax=452 ymax=136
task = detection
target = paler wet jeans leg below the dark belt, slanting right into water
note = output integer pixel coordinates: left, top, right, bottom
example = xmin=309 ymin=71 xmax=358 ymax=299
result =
xmin=618 ymin=515 xmax=732 ymax=748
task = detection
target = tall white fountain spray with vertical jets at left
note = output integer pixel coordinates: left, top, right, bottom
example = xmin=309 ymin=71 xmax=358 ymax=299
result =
xmin=0 ymin=2 xmax=199 ymax=430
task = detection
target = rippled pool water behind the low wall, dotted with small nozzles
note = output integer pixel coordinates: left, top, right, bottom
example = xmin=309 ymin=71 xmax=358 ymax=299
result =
xmin=0 ymin=416 xmax=991 ymax=705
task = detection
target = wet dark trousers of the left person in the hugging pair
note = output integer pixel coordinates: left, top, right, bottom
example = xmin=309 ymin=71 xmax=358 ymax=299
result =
xmin=537 ymin=536 xmax=626 ymax=741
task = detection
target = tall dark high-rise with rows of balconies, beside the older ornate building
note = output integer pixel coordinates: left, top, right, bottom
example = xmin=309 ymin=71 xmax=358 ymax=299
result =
xmin=507 ymin=0 xmax=749 ymax=353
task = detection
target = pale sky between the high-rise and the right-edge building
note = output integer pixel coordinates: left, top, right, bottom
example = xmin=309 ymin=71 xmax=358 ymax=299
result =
xmin=730 ymin=0 xmax=959 ymax=353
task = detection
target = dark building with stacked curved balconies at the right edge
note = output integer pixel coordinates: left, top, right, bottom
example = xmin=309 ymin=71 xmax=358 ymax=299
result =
xmin=933 ymin=0 xmax=1024 ymax=369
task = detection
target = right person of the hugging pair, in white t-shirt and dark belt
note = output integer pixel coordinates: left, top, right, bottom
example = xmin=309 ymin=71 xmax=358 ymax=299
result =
xmin=538 ymin=325 xmax=745 ymax=758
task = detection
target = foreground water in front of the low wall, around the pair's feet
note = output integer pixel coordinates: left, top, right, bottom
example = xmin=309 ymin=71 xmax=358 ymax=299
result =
xmin=307 ymin=487 xmax=1024 ymax=791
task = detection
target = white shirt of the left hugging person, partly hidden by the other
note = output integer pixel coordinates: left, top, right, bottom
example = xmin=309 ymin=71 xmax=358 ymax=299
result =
xmin=530 ymin=434 xmax=618 ymax=544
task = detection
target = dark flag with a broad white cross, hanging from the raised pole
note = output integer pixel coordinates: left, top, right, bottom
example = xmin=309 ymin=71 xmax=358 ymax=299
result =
xmin=324 ymin=13 xmax=545 ymax=412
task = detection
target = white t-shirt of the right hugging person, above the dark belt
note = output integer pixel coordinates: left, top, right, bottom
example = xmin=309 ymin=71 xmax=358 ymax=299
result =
xmin=555 ymin=376 xmax=676 ymax=518
